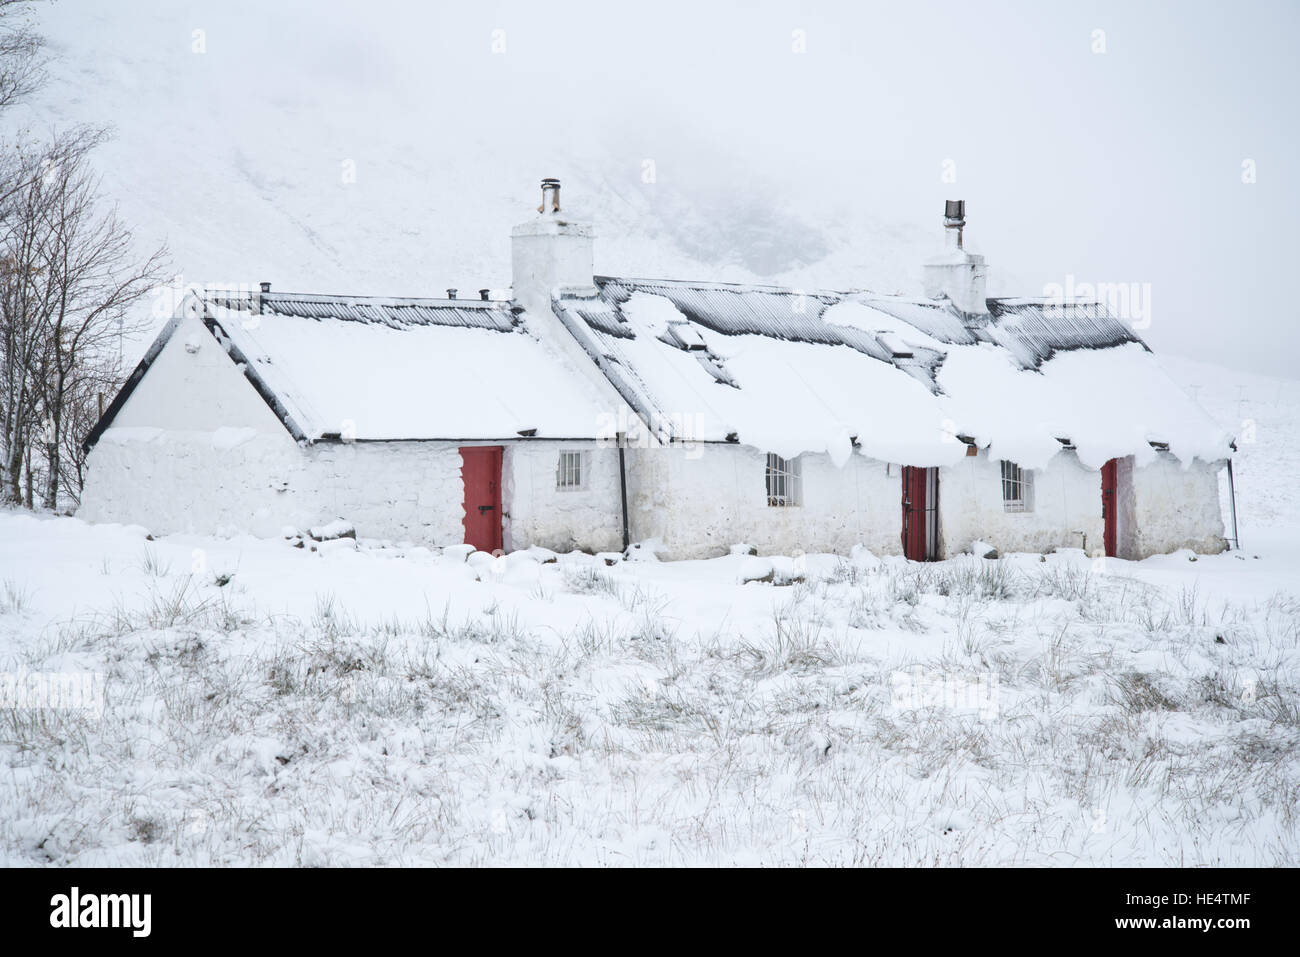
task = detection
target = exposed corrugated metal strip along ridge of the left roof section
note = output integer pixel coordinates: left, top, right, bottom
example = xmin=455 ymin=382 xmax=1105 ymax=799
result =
xmin=207 ymin=293 xmax=515 ymax=333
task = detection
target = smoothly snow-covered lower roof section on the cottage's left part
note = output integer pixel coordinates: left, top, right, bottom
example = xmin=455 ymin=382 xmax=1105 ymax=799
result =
xmin=87 ymin=293 xmax=624 ymax=445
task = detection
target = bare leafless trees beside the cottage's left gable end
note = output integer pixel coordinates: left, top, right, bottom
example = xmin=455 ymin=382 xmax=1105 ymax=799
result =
xmin=0 ymin=0 xmax=165 ymax=508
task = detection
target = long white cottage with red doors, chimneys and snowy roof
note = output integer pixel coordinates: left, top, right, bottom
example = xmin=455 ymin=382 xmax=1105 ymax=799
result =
xmin=81 ymin=179 xmax=1231 ymax=560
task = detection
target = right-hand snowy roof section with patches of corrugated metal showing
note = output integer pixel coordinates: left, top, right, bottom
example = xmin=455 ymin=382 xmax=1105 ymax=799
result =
xmin=555 ymin=277 xmax=1230 ymax=467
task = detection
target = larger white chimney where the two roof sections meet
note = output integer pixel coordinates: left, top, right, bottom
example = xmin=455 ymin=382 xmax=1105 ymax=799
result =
xmin=511 ymin=178 xmax=595 ymax=315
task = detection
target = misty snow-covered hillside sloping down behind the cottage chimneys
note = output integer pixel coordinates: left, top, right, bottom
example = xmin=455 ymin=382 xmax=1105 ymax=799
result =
xmin=15 ymin=0 xmax=940 ymax=340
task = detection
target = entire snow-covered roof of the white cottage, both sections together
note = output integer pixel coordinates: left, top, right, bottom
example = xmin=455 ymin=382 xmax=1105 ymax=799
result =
xmin=87 ymin=277 xmax=1230 ymax=468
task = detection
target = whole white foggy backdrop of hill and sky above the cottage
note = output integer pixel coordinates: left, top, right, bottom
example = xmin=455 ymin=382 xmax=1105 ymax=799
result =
xmin=9 ymin=0 xmax=1300 ymax=372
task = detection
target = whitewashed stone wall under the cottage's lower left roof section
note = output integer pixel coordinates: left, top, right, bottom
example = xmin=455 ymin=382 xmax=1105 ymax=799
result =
xmin=79 ymin=428 xmax=623 ymax=551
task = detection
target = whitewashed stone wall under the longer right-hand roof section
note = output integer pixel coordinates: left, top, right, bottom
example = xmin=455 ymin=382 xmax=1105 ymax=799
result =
xmin=628 ymin=445 xmax=1223 ymax=559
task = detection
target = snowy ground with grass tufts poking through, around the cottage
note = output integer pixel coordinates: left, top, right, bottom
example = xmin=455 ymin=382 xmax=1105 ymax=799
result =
xmin=0 ymin=363 xmax=1300 ymax=866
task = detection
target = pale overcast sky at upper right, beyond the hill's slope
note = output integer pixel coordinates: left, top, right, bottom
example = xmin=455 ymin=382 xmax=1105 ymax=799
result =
xmin=495 ymin=0 xmax=1300 ymax=374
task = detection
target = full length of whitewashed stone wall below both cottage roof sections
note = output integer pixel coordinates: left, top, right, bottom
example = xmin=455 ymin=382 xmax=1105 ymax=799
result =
xmin=79 ymin=426 xmax=1223 ymax=559
